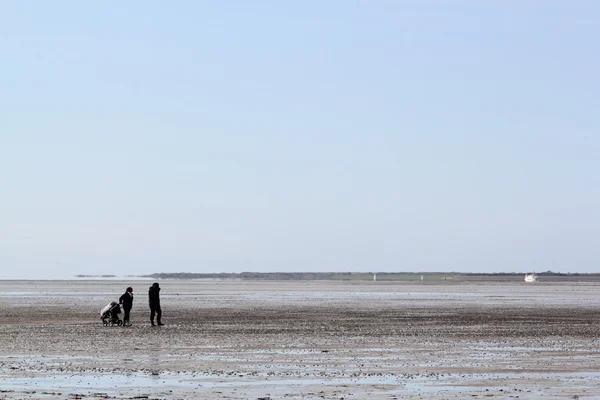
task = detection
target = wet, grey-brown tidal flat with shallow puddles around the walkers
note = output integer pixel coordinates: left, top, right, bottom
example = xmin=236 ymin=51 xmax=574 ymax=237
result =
xmin=0 ymin=280 xmax=600 ymax=399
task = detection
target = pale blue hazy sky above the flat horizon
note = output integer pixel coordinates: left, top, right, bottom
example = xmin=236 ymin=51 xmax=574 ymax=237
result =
xmin=0 ymin=0 xmax=600 ymax=279
